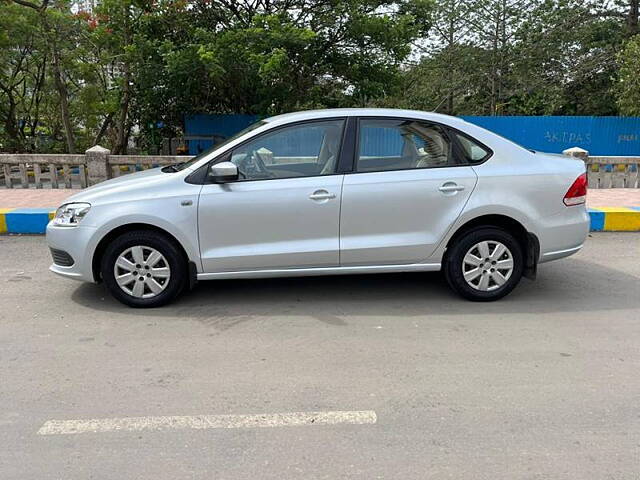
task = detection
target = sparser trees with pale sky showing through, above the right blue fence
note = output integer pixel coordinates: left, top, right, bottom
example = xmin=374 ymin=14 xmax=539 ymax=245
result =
xmin=385 ymin=0 xmax=628 ymax=115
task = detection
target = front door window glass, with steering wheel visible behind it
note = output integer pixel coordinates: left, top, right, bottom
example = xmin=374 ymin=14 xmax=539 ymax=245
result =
xmin=231 ymin=119 xmax=344 ymax=181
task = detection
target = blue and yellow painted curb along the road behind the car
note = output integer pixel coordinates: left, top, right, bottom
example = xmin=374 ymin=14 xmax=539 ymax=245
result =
xmin=0 ymin=207 xmax=640 ymax=234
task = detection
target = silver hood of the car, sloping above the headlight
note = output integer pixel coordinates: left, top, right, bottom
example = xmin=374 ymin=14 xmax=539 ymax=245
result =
xmin=64 ymin=168 xmax=175 ymax=204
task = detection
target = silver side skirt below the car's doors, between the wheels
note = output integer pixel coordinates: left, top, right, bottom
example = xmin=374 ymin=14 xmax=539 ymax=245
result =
xmin=198 ymin=263 xmax=440 ymax=280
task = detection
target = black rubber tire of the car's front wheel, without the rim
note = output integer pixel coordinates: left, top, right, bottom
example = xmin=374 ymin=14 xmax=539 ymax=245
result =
xmin=101 ymin=231 xmax=187 ymax=308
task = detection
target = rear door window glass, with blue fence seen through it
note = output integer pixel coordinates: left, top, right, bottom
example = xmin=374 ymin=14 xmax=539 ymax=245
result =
xmin=356 ymin=119 xmax=458 ymax=172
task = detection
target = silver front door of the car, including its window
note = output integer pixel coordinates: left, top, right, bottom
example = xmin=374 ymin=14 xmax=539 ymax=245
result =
xmin=198 ymin=119 xmax=344 ymax=273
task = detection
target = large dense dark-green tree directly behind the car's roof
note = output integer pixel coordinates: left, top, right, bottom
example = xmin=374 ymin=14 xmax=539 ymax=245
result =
xmin=131 ymin=0 xmax=432 ymax=150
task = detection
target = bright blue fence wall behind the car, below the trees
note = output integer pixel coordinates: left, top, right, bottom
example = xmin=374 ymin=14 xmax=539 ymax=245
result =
xmin=185 ymin=115 xmax=640 ymax=156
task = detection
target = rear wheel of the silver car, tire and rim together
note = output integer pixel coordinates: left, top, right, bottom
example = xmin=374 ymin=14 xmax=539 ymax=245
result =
xmin=443 ymin=226 xmax=524 ymax=302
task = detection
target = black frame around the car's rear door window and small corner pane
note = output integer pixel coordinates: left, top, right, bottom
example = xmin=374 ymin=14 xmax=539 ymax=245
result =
xmin=348 ymin=116 xmax=493 ymax=174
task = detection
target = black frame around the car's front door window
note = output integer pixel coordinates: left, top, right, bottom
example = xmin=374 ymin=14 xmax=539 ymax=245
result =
xmin=198 ymin=115 xmax=351 ymax=185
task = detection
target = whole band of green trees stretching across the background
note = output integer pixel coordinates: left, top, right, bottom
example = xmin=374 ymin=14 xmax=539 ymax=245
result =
xmin=0 ymin=0 xmax=640 ymax=153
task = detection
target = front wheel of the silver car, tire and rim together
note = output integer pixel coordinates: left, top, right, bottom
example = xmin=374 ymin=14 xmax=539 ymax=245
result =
xmin=100 ymin=230 xmax=188 ymax=308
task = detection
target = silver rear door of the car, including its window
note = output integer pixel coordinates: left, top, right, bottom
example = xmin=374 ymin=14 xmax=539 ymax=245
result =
xmin=340 ymin=118 xmax=477 ymax=266
